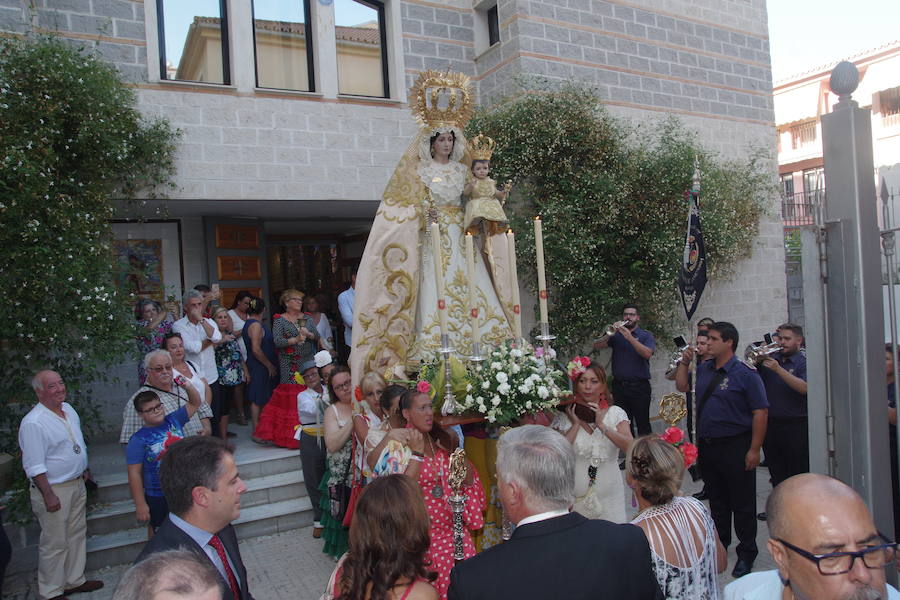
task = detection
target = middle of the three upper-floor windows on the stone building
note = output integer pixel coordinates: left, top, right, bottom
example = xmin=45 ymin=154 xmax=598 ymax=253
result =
xmin=253 ymin=0 xmax=315 ymax=92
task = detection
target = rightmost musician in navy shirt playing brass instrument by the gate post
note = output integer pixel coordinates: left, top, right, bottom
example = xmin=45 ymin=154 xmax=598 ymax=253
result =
xmin=759 ymin=323 xmax=809 ymax=510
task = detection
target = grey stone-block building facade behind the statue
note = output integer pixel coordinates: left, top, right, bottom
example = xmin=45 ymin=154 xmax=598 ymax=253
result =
xmin=0 ymin=0 xmax=786 ymax=424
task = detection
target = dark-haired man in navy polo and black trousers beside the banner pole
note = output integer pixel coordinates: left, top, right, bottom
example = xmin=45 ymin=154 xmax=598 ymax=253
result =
xmin=675 ymin=321 xmax=769 ymax=577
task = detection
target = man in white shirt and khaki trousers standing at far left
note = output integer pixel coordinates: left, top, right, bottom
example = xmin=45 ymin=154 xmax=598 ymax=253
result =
xmin=19 ymin=371 xmax=103 ymax=600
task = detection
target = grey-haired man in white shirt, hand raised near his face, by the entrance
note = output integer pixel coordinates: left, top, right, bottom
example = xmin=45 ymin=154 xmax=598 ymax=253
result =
xmin=172 ymin=290 xmax=228 ymax=439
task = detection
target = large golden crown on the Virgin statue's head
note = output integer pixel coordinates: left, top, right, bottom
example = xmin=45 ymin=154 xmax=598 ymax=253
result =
xmin=409 ymin=69 xmax=475 ymax=130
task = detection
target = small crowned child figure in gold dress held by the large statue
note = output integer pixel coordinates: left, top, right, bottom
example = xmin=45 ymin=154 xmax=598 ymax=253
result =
xmin=463 ymin=134 xmax=512 ymax=236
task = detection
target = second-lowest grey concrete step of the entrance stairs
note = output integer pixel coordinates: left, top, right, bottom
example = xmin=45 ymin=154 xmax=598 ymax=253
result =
xmin=87 ymin=471 xmax=306 ymax=536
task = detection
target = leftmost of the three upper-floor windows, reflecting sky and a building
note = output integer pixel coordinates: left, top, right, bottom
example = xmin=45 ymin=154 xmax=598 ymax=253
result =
xmin=156 ymin=0 xmax=231 ymax=84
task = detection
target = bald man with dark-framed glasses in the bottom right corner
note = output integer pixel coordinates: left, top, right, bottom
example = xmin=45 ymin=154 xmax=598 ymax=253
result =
xmin=725 ymin=473 xmax=900 ymax=600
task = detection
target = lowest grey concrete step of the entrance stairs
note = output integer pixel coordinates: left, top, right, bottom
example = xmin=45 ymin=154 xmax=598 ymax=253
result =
xmin=87 ymin=497 xmax=313 ymax=570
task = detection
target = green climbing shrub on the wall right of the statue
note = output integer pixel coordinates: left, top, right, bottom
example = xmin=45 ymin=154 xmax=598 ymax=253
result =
xmin=467 ymin=79 xmax=773 ymax=353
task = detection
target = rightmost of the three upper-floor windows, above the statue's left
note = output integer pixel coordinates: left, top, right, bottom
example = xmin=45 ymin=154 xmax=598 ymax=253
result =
xmin=334 ymin=0 xmax=390 ymax=98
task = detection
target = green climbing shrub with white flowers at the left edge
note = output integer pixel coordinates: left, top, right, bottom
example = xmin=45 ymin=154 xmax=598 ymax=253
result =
xmin=0 ymin=37 xmax=177 ymax=516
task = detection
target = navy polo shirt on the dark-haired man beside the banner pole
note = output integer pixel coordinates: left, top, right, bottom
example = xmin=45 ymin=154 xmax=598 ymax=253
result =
xmin=695 ymin=356 xmax=769 ymax=438
